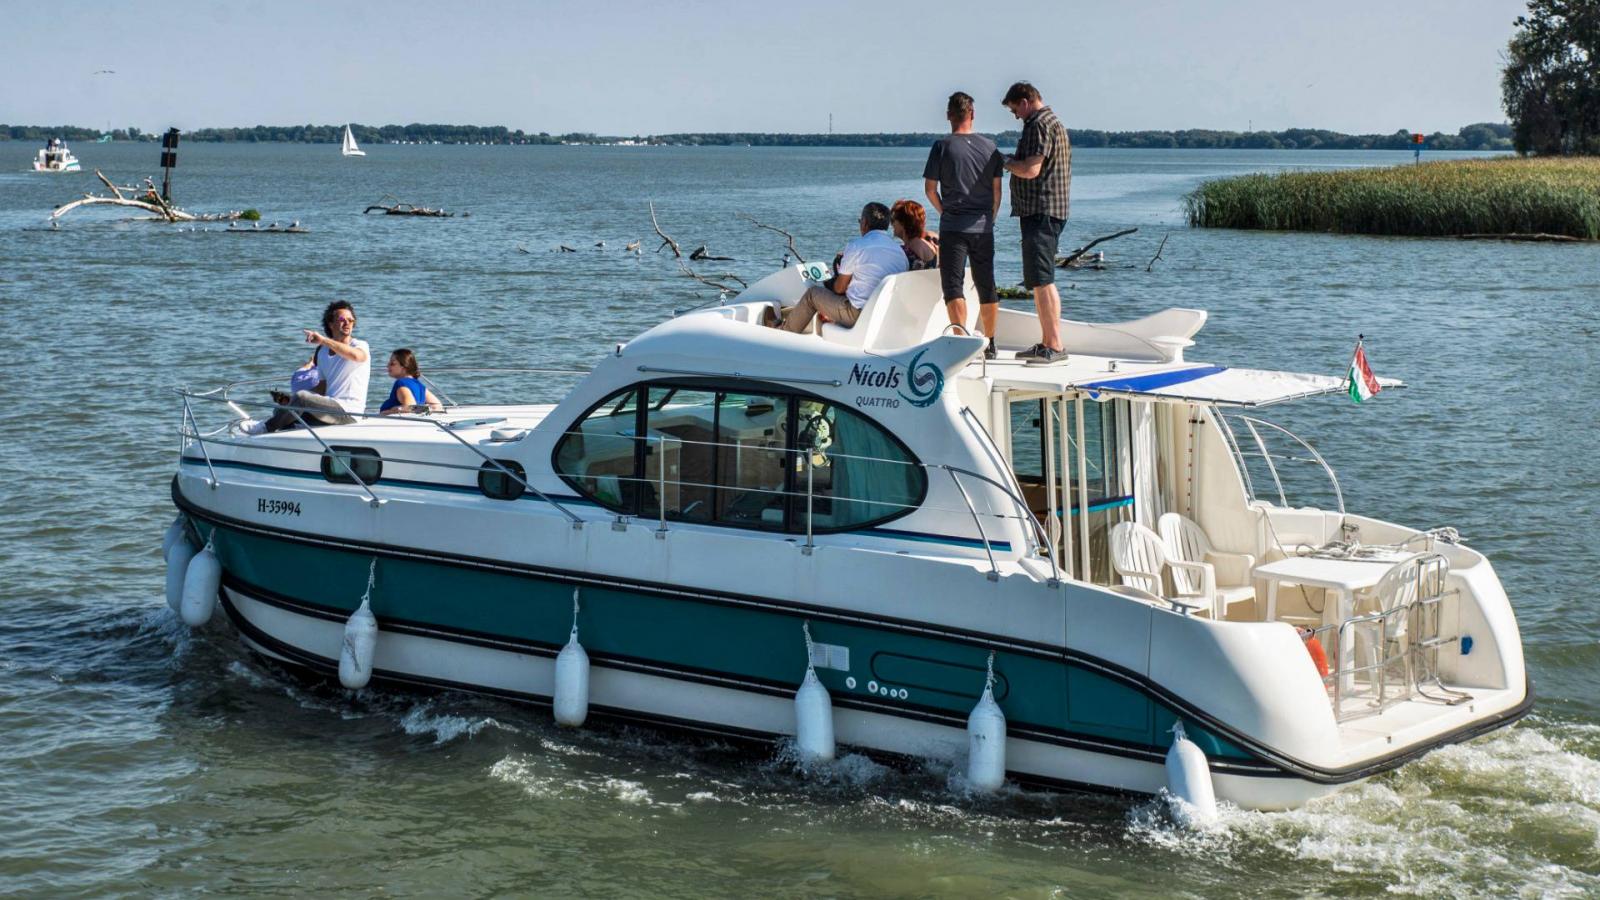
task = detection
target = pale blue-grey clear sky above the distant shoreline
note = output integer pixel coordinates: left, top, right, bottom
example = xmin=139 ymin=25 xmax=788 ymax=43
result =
xmin=0 ymin=0 xmax=1525 ymax=135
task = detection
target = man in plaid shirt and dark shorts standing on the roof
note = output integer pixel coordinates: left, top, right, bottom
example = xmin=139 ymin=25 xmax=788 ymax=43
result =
xmin=1000 ymin=82 xmax=1072 ymax=365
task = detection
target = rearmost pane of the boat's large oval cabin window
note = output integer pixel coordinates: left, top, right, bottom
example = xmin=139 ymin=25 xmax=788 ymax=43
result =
xmin=794 ymin=397 xmax=928 ymax=530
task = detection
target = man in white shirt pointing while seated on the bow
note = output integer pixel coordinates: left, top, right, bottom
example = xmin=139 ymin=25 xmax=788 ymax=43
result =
xmin=245 ymin=299 xmax=373 ymax=434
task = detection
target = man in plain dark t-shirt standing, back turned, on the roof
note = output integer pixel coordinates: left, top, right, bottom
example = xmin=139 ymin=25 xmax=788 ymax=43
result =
xmin=922 ymin=91 xmax=1005 ymax=359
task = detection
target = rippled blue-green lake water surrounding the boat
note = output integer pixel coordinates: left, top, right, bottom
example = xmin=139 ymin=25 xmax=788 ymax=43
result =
xmin=0 ymin=144 xmax=1600 ymax=897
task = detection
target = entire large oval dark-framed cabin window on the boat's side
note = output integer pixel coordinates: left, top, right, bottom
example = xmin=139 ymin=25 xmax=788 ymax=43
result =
xmin=555 ymin=383 xmax=928 ymax=533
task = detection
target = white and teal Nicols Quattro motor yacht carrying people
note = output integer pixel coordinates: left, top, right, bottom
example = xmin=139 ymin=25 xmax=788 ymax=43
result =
xmin=171 ymin=267 xmax=1531 ymax=809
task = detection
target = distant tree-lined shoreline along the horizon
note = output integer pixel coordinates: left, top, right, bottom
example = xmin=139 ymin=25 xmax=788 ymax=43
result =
xmin=0 ymin=122 xmax=1512 ymax=151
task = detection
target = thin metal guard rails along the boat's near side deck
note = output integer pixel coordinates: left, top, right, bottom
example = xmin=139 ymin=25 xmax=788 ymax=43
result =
xmin=176 ymin=385 xmax=1061 ymax=585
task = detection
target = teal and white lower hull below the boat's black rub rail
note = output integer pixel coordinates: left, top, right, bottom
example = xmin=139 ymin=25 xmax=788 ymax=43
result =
xmin=174 ymin=482 xmax=1525 ymax=809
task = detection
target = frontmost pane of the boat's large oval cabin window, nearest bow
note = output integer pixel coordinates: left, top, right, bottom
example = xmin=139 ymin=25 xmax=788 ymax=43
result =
xmin=555 ymin=388 xmax=642 ymax=512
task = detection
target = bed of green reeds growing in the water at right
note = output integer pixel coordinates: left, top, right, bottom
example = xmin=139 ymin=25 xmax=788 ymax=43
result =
xmin=1184 ymin=157 xmax=1600 ymax=240
